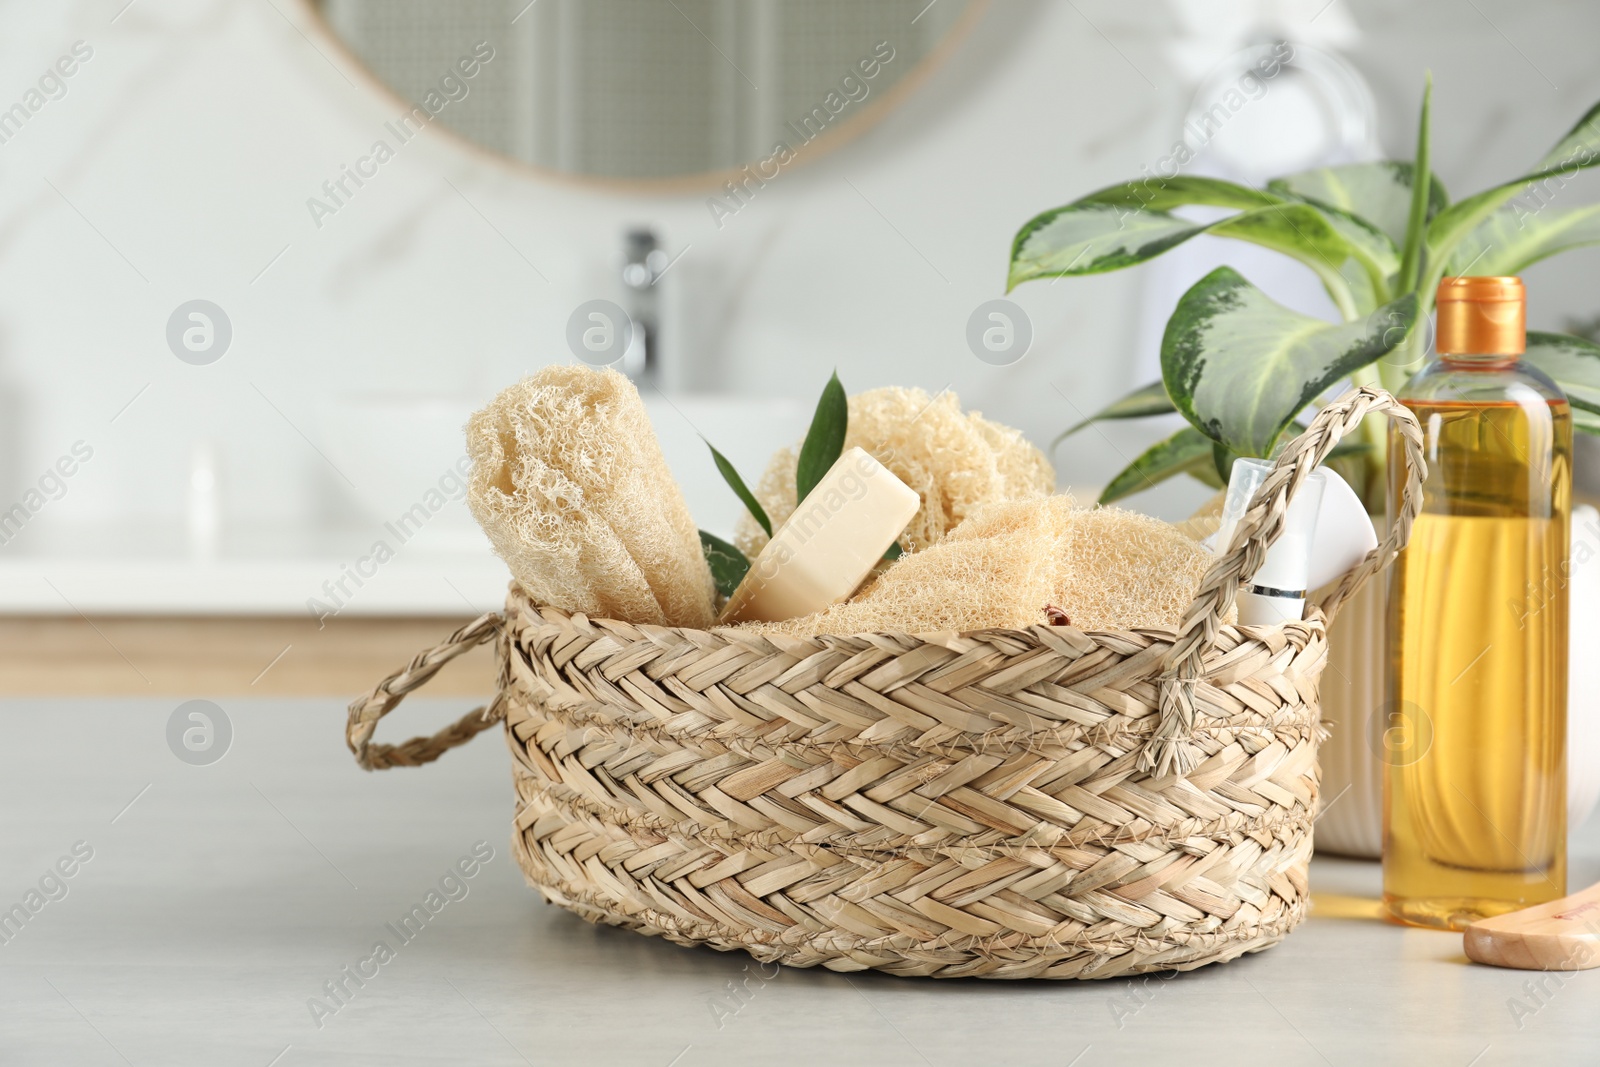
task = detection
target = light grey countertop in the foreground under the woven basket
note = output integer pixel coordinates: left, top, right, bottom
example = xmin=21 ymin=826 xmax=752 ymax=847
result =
xmin=0 ymin=700 xmax=1600 ymax=1067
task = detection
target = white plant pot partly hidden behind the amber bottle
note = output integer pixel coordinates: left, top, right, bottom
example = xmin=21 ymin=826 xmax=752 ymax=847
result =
xmin=1317 ymin=506 xmax=1600 ymax=859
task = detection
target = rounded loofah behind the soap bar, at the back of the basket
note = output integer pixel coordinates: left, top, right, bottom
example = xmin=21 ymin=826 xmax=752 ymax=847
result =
xmin=734 ymin=387 xmax=1056 ymax=560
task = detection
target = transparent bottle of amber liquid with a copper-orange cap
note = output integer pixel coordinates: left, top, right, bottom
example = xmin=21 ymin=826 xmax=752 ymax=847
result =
xmin=1381 ymin=278 xmax=1571 ymax=929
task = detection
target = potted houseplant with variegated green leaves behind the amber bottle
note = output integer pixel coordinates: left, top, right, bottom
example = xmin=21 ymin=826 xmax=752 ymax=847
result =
xmin=1008 ymin=78 xmax=1600 ymax=854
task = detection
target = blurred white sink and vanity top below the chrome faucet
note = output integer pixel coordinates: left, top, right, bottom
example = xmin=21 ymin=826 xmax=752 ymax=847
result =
xmin=0 ymin=390 xmax=810 ymax=616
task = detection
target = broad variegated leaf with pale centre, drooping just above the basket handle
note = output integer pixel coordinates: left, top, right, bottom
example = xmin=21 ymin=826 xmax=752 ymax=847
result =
xmin=1162 ymin=267 xmax=1416 ymax=456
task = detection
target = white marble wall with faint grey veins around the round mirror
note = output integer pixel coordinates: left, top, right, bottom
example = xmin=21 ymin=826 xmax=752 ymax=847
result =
xmin=0 ymin=0 xmax=1600 ymax=563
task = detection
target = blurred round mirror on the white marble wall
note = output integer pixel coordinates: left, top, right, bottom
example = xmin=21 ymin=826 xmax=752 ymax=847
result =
xmin=310 ymin=0 xmax=984 ymax=184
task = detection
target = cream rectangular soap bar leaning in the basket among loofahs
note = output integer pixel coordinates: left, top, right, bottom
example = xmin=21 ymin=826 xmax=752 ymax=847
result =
xmin=722 ymin=448 xmax=922 ymax=622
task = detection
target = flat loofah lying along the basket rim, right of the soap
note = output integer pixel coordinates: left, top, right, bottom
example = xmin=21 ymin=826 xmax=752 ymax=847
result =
xmin=736 ymin=496 xmax=1214 ymax=635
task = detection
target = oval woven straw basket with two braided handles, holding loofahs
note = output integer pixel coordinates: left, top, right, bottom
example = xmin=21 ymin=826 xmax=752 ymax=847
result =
xmin=349 ymin=389 xmax=1424 ymax=977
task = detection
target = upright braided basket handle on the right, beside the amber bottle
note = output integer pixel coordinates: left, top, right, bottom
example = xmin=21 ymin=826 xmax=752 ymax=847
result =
xmin=1139 ymin=386 xmax=1427 ymax=774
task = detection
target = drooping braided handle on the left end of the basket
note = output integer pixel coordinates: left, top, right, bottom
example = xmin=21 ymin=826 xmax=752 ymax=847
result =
xmin=344 ymin=611 xmax=506 ymax=771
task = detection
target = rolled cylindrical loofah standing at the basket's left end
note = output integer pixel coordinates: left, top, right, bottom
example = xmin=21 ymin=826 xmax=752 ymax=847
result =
xmin=467 ymin=365 xmax=715 ymax=629
